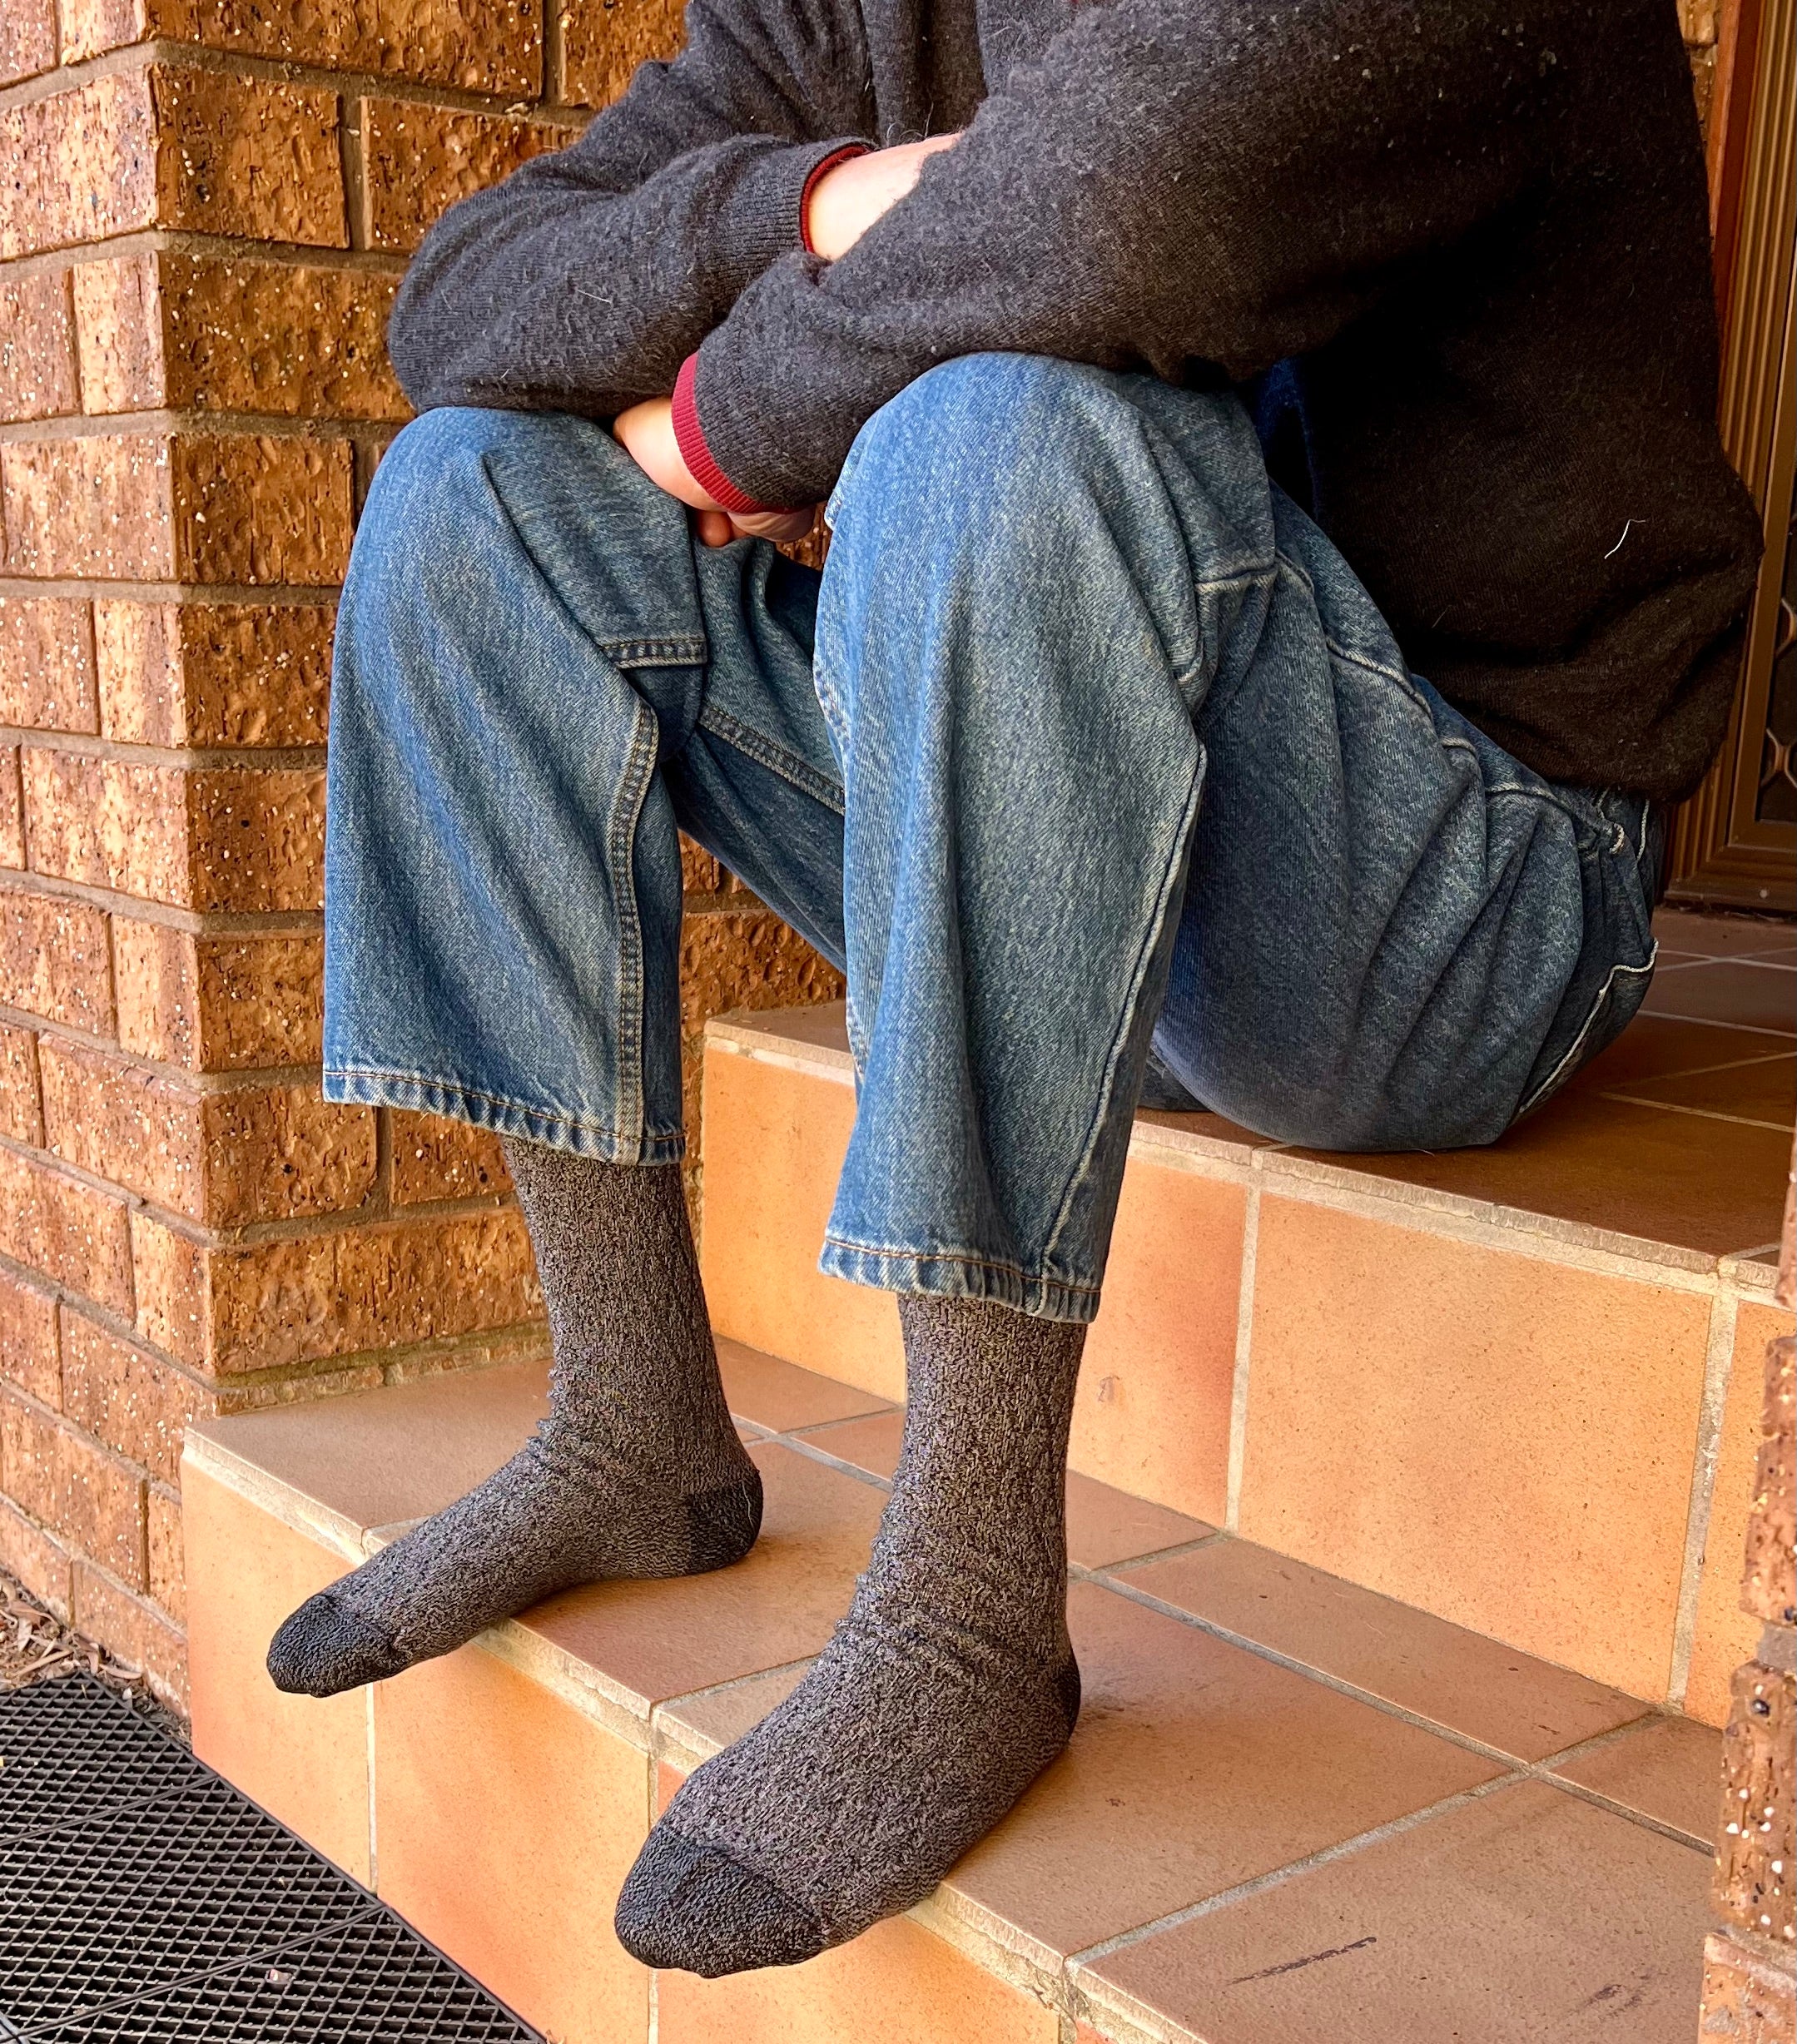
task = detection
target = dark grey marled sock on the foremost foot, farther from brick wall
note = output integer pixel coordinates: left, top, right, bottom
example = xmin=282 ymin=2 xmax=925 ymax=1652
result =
xmin=618 ymin=1298 xmax=1085 ymax=1977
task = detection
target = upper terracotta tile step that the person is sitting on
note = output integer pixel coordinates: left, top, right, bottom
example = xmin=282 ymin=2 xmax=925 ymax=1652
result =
xmin=703 ymin=911 xmax=1797 ymax=1723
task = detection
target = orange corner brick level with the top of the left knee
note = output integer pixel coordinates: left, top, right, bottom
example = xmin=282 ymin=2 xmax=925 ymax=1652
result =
xmin=0 ymin=434 xmax=354 ymax=587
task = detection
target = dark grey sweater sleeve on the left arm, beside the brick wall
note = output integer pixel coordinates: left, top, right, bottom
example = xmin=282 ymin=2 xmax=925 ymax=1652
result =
xmin=386 ymin=0 xmax=873 ymax=417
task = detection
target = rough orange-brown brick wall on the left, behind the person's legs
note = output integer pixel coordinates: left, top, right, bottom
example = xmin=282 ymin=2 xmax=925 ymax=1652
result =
xmin=0 ymin=0 xmax=836 ymax=1700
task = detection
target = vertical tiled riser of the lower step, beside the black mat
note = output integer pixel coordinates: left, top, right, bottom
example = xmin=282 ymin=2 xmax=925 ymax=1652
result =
xmin=182 ymin=1461 xmax=1061 ymax=2044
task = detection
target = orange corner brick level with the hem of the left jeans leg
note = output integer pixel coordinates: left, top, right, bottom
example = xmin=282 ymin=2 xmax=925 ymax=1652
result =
xmin=39 ymin=1043 xmax=374 ymax=1228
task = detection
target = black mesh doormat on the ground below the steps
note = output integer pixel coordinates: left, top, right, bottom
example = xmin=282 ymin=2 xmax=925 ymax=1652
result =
xmin=0 ymin=1674 xmax=536 ymax=2044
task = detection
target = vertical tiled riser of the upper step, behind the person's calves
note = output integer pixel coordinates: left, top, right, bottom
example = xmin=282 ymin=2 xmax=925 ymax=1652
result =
xmin=703 ymin=1024 xmax=1780 ymax=1723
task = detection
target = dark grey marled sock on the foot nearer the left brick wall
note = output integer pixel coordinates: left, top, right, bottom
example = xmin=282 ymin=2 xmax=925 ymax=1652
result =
xmin=268 ymin=1140 xmax=761 ymax=1696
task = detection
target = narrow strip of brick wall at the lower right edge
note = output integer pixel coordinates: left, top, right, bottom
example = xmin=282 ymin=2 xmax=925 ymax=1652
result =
xmin=1699 ymin=1183 xmax=1797 ymax=2044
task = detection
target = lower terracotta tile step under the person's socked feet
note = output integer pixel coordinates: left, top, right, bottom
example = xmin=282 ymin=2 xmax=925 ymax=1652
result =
xmin=184 ymin=1343 xmax=1720 ymax=2044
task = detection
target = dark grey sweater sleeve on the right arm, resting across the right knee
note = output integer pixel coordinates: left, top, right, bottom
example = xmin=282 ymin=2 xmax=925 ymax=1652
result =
xmin=685 ymin=0 xmax=1572 ymax=505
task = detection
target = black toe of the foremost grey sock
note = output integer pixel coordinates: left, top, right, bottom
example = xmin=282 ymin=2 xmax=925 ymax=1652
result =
xmin=618 ymin=1823 xmax=824 ymax=1981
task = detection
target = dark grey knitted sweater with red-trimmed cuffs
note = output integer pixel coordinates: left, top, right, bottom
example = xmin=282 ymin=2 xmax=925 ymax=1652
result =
xmin=389 ymin=0 xmax=1758 ymax=797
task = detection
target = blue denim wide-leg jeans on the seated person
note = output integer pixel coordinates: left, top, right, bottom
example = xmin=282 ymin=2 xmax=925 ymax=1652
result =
xmin=325 ymin=355 xmax=1656 ymax=1321
